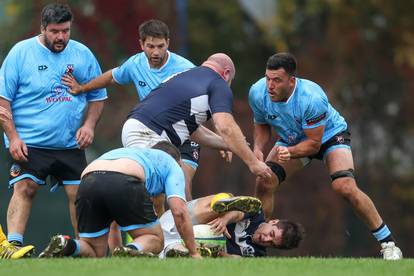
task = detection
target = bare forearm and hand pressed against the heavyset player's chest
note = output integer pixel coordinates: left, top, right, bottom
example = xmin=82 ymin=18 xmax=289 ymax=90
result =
xmin=62 ymin=69 xmax=115 ymax=95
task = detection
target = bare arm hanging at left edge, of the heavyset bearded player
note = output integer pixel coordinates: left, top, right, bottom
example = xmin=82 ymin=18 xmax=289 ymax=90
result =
xmin=0 ymin=97 xmax=28 ymax=161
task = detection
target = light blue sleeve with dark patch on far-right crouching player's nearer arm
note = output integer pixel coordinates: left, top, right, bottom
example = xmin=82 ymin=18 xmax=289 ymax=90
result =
xmin=302 ymin=91 xmax=328 ymax=129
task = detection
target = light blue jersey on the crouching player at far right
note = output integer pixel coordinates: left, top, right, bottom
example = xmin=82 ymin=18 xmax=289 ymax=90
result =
xmin=249 ymin=78 xmax=347 ymax=146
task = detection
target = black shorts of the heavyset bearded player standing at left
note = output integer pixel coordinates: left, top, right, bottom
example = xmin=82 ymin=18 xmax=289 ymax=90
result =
xmin=9 ymin=147 xmax=86 ymax=187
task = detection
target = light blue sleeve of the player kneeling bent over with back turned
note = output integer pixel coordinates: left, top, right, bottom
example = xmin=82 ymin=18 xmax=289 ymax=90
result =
xmin=165 ymin=161 xmax=185 ymax=201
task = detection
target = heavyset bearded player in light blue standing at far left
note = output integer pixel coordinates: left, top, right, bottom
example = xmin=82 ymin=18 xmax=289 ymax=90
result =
xmin=0 ymin=4 xmax=107 ymax=254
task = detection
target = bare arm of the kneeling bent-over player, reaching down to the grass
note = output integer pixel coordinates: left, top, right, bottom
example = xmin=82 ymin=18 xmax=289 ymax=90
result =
xmin=168 ymin=197 xmax=199 ymax=257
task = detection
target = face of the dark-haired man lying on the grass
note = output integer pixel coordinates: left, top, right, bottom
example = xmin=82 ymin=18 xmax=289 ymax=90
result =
xmin=252 ymin=220 xmax=282 ymax=247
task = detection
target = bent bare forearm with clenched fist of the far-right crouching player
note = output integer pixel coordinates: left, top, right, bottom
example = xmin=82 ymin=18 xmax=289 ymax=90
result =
xmin=287 ymin=126 xmax=325 ymax=158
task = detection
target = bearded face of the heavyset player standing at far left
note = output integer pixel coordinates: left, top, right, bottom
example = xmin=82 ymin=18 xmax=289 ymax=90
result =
xmin=41 ymin=21 xmax=72 ymax=53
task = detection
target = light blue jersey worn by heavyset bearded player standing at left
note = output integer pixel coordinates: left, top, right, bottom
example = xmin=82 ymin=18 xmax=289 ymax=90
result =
xmin=0 ymin=36 xmax=107 ymax=149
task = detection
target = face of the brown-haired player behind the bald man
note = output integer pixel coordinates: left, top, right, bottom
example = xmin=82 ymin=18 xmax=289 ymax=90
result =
xmin=139 ymin=36 xmax=169 ymax=68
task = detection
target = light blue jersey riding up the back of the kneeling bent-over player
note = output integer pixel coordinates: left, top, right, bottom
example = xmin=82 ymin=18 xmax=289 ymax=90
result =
xmin=98 ymin=148 xmax=185 ymax=201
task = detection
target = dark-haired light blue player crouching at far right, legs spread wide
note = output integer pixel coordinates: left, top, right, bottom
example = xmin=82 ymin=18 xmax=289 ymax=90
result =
xmin=249 ymin=53 xmax=402 ymax=260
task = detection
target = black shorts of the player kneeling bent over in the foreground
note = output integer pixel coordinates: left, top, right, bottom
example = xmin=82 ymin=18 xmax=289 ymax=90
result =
xmin=75 ymin=171 xmax=158 ymax=238
